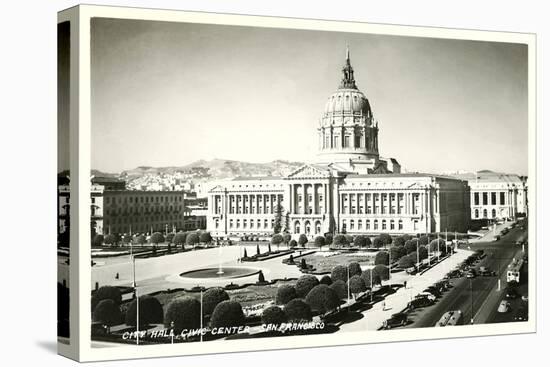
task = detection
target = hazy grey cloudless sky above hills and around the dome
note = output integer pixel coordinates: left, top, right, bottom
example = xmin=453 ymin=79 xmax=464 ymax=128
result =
xmin=91 ymin=18 xmax=528 ymax=175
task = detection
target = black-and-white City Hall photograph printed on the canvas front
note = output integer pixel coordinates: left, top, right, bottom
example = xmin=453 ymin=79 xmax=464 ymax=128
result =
xmin=54 ymin=4 xmax=535 ymax=364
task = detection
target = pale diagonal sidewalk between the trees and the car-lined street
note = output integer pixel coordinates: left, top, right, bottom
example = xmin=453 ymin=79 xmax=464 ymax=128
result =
xmin=340 ymin=249 xmax=472 ymax=332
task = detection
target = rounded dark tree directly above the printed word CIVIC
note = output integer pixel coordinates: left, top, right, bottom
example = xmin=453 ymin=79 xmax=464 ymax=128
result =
xmin=164 ymin=296 xmax=201 ymax=334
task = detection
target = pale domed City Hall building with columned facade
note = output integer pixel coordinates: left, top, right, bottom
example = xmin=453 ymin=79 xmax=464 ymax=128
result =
xmin=207 ymin=51 xmax=470 ymax=238
